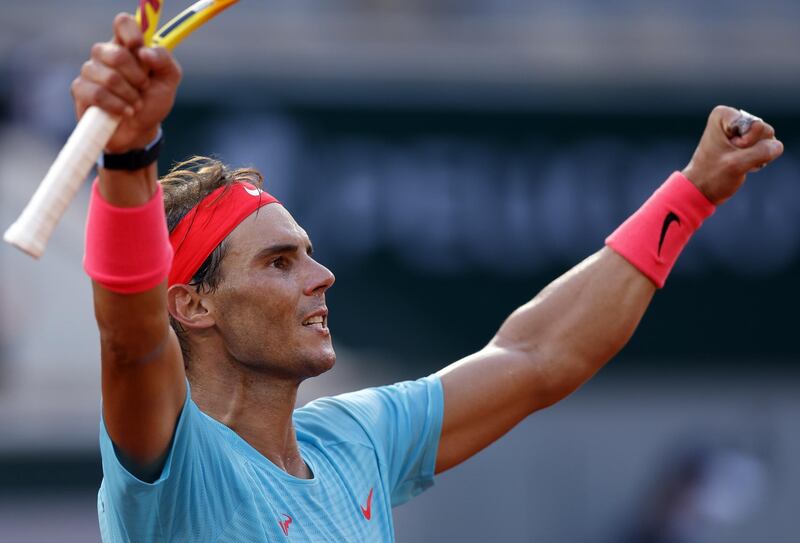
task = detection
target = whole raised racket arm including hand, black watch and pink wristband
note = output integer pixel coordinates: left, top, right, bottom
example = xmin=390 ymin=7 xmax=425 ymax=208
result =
xmin=72 ymin=14 xmax=186 ymax=479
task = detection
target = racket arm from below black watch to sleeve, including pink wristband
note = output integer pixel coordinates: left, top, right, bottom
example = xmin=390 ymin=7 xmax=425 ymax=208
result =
xmin=92 ymin=159 xmax=185 ymax=470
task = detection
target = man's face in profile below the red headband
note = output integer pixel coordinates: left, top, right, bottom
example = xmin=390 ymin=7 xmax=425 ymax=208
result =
xmin=208 ymin=204 xmax=336 ymax=380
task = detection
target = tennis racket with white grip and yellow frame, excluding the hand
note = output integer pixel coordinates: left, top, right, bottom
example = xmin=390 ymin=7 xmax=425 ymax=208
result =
xmin=3 ymin=0 xmax=238 ymax=258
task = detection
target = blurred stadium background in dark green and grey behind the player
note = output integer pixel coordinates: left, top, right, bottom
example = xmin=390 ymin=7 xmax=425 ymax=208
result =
xmin=0 ymin=0 xmax=800 ymax=543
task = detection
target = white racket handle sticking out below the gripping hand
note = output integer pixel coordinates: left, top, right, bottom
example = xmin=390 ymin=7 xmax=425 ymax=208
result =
xmin=3 ymin=106 xmax=120 ymax=258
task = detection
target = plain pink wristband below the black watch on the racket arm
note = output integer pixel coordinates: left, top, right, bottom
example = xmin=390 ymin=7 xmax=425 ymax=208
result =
xmin=83 ymin=180 xmax=172 ymax=294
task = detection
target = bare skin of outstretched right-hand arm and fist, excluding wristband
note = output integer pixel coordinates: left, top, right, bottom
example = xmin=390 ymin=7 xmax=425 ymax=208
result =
xmin=436 ymin=106 xmax=783 ymax=473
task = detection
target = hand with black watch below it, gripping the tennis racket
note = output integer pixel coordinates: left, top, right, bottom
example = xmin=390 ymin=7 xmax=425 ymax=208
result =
xmin=72 ymin=13 xmax=181 ymax=153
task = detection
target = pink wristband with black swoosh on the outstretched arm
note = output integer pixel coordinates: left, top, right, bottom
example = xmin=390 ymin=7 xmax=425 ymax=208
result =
xmin=606 ymin=172 xmax=716 ymax=288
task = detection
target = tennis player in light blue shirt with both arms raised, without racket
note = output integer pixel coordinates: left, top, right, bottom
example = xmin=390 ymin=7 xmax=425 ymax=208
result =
xmin=72 ymin=14 xmax=783 ymax=543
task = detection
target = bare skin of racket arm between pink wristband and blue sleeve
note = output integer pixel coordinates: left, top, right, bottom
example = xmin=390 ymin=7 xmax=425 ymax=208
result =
xmin=92 ymin=268 xmax=186 ymax=481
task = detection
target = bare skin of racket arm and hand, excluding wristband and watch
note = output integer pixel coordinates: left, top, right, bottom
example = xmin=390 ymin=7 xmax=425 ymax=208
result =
xmin=72 ymin=14 xmax=186 ymax=479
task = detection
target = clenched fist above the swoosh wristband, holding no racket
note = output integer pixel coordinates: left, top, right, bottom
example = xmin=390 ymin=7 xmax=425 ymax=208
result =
xmin=683 ymin=106 xmax=783 ymax=205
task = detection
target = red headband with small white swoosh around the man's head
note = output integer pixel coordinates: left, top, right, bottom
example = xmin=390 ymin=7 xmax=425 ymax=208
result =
xmin=167 ymin=181 xmax=280 ymax=286
